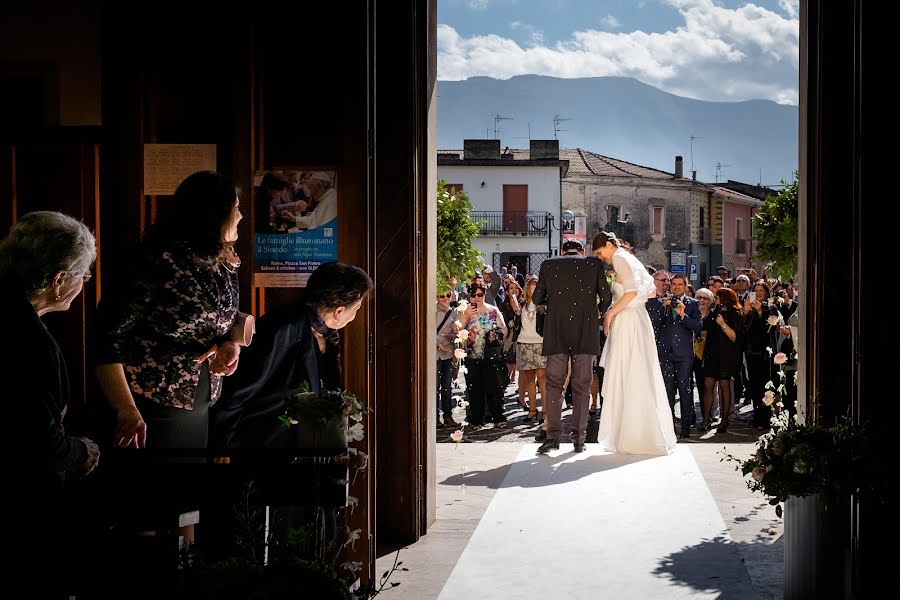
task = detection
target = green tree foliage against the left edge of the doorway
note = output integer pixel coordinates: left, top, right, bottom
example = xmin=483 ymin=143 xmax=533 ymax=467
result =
xmin=437 ymin=179 xmax=481 ymax=293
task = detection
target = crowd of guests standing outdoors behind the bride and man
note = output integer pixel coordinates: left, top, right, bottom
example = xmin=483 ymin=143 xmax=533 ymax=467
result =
xmin=437 ymin=250 xmax=799 ymax=441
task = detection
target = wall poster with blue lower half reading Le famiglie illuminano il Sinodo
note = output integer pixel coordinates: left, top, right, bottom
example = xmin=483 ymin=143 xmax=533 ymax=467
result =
xmin=253 ymin=168 xmax=337 ymax=287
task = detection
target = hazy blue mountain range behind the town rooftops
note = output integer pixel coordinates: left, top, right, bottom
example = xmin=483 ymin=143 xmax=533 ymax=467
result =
xmin=438 ymin=75 xmax=799 ymax=185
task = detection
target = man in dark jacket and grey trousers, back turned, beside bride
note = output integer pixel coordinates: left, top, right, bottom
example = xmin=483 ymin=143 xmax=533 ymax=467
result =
xmin=532 ymin=240 xmax=612 ymax=454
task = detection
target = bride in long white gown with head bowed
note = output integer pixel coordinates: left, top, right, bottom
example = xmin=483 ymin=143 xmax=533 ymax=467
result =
xmin=593 ymin=231 xmax=675 ymax=455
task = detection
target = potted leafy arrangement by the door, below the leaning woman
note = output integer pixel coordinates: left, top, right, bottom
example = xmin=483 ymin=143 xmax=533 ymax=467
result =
xmin=279 ymin=385 xmax=366 ymax=448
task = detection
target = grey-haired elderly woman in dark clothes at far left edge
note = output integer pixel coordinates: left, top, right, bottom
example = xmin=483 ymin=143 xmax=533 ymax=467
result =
xmin=0 ymin=211 xmax=100 ymax=597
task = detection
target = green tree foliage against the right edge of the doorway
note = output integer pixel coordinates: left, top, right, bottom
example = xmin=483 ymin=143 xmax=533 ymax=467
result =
xmin=753 ymin=171 xmax=798 ymax=281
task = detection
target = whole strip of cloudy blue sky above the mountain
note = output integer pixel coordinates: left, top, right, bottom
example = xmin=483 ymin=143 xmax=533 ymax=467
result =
xmin=438 ymin=0 xmax=799 ymax=104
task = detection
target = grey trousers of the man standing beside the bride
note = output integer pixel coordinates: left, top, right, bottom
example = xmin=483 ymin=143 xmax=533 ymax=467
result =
xmin=543 ymin=354 xmax=596 ymax=444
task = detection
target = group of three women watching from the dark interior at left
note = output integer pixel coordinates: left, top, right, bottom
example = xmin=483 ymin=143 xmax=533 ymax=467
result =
xmin=0 ymin=172 xmax=373 ymax=592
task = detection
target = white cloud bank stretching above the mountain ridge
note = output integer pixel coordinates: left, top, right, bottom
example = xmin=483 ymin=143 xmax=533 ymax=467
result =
xmin=438 ymin=0 xmax=800 ymax=104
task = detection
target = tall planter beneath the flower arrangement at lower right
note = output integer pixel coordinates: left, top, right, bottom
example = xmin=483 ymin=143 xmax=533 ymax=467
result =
xmin=784 ymin=494 xmax=850 ymax=600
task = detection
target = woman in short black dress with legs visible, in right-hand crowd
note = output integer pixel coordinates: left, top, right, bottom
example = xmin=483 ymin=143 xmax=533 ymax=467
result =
xmin=703 ymin=288 xmax=744 ymax=433
